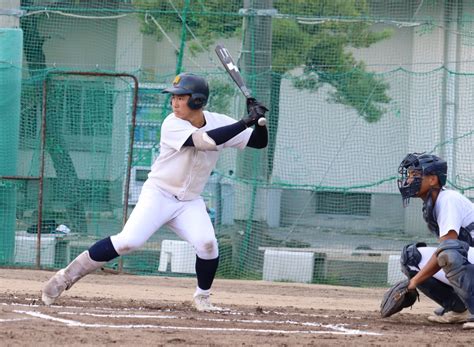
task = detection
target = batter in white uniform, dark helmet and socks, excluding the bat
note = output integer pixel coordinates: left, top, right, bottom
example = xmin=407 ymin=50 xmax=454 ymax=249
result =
xmin=42 ymin=73 xmax=268 ymax=311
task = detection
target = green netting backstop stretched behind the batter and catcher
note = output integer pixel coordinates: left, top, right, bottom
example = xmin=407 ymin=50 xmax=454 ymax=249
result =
xmin=0 ymin=0 xmax=474 ymax=286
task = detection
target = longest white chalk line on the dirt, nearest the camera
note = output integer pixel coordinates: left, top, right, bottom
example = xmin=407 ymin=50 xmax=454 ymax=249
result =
xmin=13 ymin=310 xmax=381 ymax=335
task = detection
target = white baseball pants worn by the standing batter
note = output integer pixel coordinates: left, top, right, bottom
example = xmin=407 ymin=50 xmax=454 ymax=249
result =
xmin=110 ymin=180 xmax=219 ymax=259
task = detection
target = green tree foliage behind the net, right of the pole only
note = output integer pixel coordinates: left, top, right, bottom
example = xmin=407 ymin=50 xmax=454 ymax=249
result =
xmin=272 ymin=0 xmax=391 ymax=123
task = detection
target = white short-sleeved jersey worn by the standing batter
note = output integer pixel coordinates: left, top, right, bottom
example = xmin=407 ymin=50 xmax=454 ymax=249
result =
xmin=148 ymin=111 xmax=252 ymax=200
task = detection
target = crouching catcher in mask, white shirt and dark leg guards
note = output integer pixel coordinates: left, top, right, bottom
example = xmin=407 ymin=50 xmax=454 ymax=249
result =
xmin=380 ymin=153 xmax=474 ymax=329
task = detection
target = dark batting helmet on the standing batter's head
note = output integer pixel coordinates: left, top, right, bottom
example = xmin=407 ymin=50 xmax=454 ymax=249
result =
xmin=163 ymin=73 xmax=209 ymax=110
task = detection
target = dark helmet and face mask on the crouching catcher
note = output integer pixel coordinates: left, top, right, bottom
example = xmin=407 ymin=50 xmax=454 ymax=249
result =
xmin=397 ymin=153 xmax=448 ymax=207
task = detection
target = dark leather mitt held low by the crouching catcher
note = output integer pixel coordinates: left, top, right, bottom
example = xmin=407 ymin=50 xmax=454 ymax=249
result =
xmin=380 ymin=280 xmax=419 ymax=318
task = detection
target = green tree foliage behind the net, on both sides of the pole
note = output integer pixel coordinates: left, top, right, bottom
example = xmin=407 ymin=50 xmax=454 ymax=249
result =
xmin=135 ymin=0 xmax=391 ymax=122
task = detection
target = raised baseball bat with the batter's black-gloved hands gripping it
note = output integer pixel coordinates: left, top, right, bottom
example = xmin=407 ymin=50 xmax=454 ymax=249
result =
xmin=216 ymin=44 xmax=268 ymax=126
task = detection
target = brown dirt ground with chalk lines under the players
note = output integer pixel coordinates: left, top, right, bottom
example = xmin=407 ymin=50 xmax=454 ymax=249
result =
xmin=0 ymin=269 xmax=473 ymax=346
